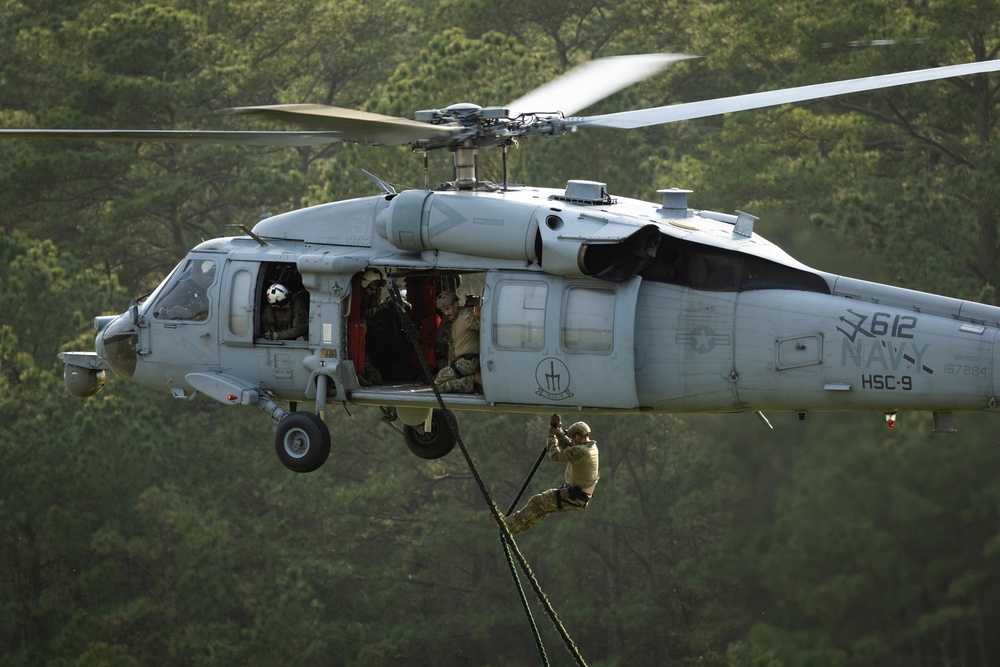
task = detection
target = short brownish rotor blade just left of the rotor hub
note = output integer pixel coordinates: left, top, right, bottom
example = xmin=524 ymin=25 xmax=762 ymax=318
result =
xmin=220 ymin=104 xmax=457 ymax=146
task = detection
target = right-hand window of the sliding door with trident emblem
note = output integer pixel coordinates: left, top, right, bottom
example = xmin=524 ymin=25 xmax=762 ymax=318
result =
xmin=559 ymin=285 xmax=615 ymax=354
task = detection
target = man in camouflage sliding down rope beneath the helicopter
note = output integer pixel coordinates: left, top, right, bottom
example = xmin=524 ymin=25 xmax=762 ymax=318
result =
xmin=490 ymin=415 xmax=601 ymax=535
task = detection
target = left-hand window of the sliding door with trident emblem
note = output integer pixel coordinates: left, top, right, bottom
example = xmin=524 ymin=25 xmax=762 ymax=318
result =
xmin=493 ymin=282 xmax=548 ymax=350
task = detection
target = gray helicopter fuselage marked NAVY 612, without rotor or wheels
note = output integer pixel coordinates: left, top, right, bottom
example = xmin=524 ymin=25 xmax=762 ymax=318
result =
xmin=74 ymin=181 xmax=1000 ymax=423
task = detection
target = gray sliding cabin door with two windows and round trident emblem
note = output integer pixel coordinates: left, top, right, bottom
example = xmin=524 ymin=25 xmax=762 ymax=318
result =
xmin=480 ymin=271 xmax=641 ymax=409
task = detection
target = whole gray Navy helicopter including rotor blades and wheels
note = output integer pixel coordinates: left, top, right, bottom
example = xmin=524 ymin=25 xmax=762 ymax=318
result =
xmin=7 ymin=54 xmax=1000 ymax=472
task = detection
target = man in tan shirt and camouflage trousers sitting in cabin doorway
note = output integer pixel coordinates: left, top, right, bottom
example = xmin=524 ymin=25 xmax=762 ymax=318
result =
xmin=434 ymin=291 xmax=483 ymax=394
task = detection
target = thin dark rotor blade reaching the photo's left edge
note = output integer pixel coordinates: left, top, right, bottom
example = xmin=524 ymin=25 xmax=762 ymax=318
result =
xmin=0 ymin=130 xmax=344 ymax=146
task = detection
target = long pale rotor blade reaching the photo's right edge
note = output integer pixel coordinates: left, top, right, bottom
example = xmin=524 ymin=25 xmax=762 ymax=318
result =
xmin=566 ymin=60 xmax=1000 ymax=130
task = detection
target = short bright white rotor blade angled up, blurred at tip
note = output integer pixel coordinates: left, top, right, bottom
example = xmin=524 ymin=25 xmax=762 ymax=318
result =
xmin=507 ymin=53 xmax=697 ymax=118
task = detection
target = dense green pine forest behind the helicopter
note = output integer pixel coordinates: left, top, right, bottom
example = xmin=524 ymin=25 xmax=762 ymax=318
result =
xmin=0 ymin=0 xmax=1000 ymax=667
